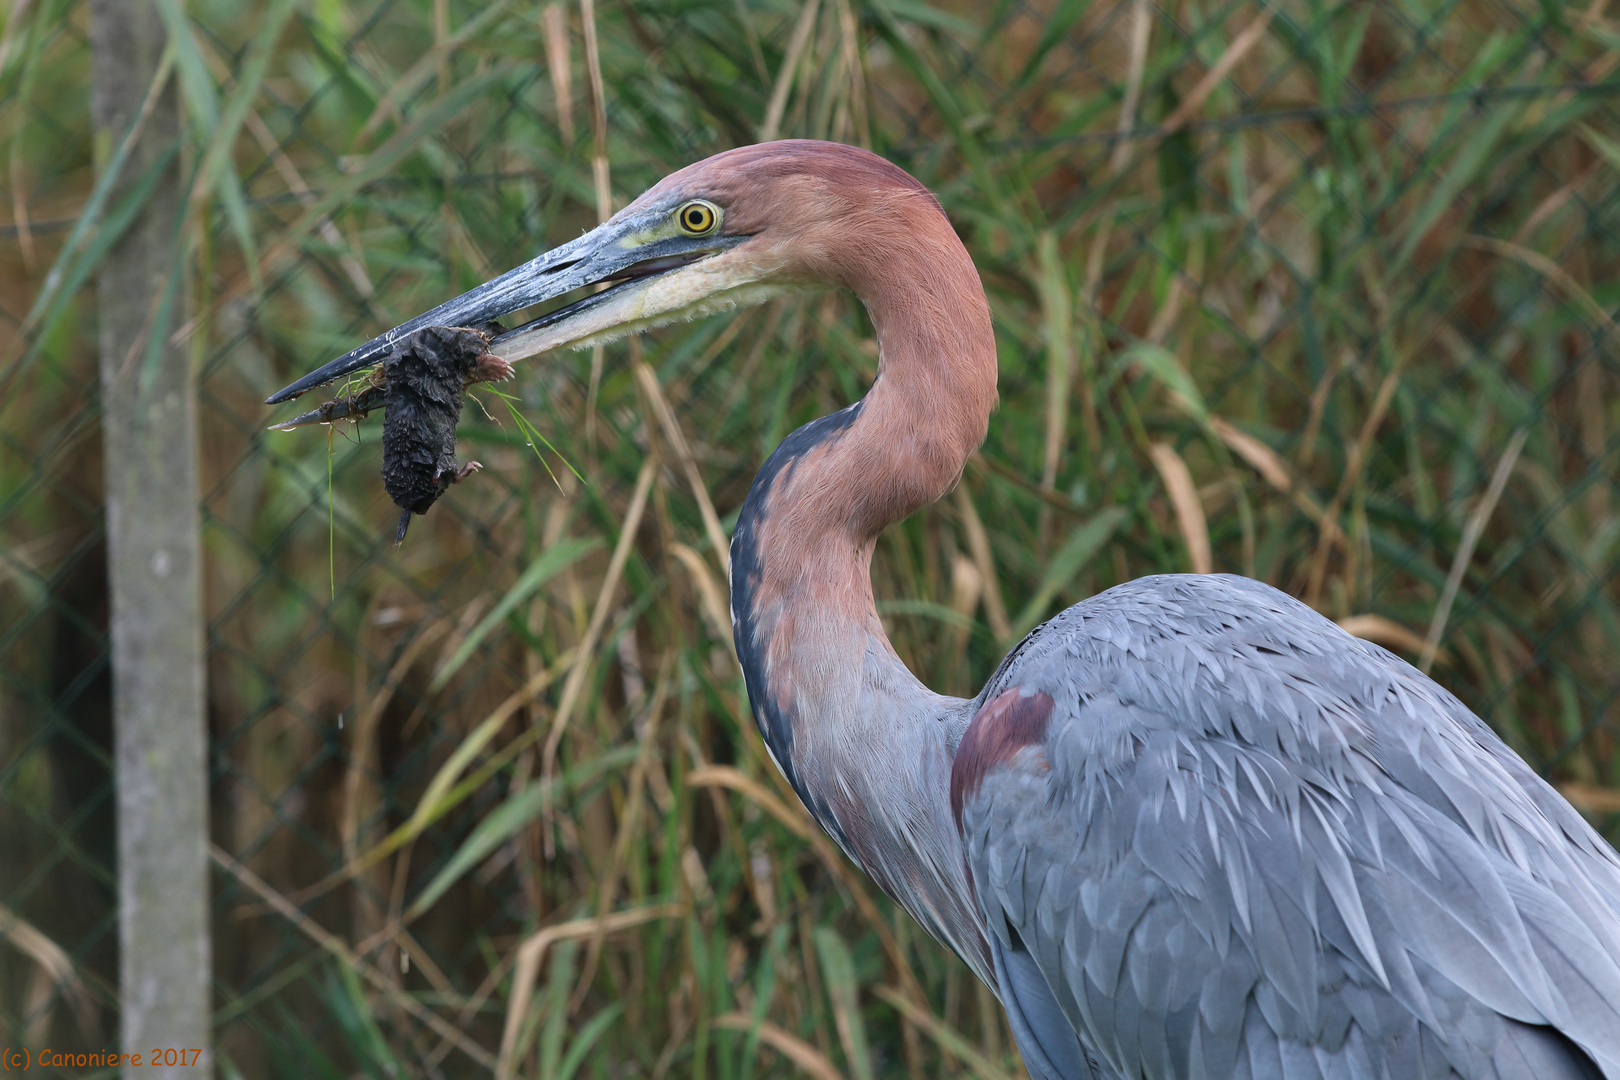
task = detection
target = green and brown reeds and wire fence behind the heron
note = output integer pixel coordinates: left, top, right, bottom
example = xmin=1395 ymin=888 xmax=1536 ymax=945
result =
xmin=0 ymin=0 xmax=1620 ymax=1080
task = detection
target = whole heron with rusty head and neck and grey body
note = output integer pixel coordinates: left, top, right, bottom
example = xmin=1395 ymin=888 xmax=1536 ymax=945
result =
xmin=269 ymin=139 xmax=1620 ymax=1080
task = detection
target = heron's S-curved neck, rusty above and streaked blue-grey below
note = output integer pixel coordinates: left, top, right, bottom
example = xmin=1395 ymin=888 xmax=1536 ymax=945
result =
xmin=731 ymin=188 xmax=996 ymax=984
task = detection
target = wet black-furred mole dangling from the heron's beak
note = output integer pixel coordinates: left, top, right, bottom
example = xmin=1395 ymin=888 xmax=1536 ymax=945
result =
xmin=382 ymin=325 xmax=489 ymax=546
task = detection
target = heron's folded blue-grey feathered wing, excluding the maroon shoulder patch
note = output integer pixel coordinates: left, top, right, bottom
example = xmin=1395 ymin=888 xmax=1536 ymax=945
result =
xmin=962 ymin=576 xmax=1620 ymax=1080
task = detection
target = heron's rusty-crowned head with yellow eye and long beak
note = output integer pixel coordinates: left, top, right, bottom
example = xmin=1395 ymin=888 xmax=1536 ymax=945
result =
xmin=269 ymin=139 xmax=946 ymax=405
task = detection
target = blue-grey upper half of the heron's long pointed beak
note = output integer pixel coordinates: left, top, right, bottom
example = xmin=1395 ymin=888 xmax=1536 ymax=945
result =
xmin=264 ymin=210 xmax=747 ymax=405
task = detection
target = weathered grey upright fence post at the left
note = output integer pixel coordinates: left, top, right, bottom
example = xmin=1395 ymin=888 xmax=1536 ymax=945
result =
xmin=89 ymin=0 xmax=212 ymax=1080
